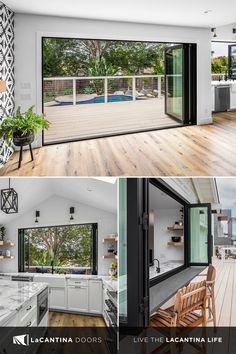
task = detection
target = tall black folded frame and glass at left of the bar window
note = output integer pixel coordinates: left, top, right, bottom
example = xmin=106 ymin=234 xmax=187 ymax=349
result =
xmin=119 ymin=178 xmax=149 ymax=327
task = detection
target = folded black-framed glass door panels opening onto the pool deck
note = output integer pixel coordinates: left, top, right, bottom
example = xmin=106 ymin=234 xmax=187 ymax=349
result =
xmin=165 ymin=43 xmax=197 ymax=124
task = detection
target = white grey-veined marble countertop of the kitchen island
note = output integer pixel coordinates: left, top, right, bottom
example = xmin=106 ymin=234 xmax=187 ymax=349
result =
xmin=0 ymin=279 xmax=48 ymax=326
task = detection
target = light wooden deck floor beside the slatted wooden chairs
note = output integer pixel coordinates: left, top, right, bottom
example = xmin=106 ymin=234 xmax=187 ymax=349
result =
xmin=162 ymin=257 xmax=236 ymax=327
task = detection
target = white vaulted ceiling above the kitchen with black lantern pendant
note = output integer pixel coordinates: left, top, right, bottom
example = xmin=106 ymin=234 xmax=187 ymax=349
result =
xmin=0 ymin=178 xmax=117 ymax=224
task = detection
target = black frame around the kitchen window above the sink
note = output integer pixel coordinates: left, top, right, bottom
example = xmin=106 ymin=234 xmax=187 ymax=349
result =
xmin=18 ymin=223 xmax=98 ymax=275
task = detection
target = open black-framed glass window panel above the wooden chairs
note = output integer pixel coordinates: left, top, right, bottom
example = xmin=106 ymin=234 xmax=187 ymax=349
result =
xmin=186 ymin=204 xmax=212 ymax=265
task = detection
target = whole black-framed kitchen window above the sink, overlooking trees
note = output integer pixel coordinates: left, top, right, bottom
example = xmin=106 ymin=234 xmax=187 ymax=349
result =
xmin=19 ymin=224 xmax=97 ymax=274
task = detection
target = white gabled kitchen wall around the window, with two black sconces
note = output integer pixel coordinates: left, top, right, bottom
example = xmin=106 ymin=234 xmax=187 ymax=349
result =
xmin=0 ymin=196 xmax=117 ymax=275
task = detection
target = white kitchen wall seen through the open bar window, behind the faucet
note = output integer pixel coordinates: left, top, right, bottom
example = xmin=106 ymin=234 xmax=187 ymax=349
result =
xmin=153 ymin=206 xmax=184 ymax=264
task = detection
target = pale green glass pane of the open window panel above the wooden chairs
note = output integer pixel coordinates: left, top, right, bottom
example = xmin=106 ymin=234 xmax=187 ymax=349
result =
xmin=190 ymin=207 xmax=208 ymax=263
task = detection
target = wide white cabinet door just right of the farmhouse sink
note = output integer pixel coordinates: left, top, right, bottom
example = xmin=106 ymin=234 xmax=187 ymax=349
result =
xmin=67 ymin=285 xmax=88 ymax=312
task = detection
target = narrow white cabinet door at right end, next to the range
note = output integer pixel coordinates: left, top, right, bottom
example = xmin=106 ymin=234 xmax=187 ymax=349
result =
xmin=89 ymin=280 xmax=103 ymax=314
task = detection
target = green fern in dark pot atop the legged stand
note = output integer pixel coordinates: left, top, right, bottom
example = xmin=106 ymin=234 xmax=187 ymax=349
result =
xmin=0 ymin=106 xmax=50 ymax=146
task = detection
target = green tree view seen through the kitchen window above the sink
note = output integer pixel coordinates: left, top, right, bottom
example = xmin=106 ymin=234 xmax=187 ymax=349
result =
xmin=25 ymin=225 xmax=92 ymax=267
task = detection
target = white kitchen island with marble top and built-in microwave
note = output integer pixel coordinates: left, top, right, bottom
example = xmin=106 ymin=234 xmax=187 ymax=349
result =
xmin=0 ymin=279 xmax=48 ymax=327
